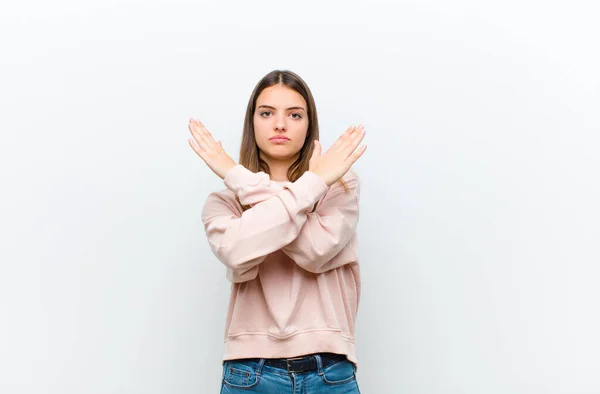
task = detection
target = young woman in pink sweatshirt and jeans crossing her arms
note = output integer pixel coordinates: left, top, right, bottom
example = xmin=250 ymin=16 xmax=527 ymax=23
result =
xmin=189 ymin=70 xmax=366 ymax=394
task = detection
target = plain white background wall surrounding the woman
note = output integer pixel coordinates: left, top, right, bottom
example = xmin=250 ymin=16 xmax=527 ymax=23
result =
xmin=0 ymin=0 xmax=600 ymax=394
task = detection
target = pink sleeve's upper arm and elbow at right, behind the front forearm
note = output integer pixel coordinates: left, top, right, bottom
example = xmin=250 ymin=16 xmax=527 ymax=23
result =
xmin=282 ymin=173 xmax=360 ymax=274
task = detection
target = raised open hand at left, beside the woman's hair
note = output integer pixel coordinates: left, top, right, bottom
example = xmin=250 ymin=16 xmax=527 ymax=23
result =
xmin=188 ymin=118 xmax=236 ymax=179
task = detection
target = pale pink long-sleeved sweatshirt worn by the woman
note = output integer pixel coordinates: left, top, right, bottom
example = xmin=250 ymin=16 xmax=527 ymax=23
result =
xmin=202 ymin=164 xmax=360 ymax=365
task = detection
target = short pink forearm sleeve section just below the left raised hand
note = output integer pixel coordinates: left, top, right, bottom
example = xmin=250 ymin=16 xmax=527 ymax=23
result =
xmin=223 ymin=164 xmax=283 ymax=206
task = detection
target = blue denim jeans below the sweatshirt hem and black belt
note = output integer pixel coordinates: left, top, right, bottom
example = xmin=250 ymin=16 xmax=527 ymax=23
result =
xmin=221 ymin=355 xmax=360 ymax=394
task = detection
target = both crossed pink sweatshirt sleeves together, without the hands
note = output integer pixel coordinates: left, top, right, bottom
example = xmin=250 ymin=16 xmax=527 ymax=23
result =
xmin=202 ymin=164 xmax=359 ymax=283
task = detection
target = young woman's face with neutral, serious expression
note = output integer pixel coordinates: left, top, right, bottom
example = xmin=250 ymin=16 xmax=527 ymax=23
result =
xmin=253 ymin=85 xmax=308 ymax=167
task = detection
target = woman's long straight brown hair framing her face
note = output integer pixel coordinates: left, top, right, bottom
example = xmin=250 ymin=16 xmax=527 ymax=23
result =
xmin=238 ymin=70 xmax=348 ymax=210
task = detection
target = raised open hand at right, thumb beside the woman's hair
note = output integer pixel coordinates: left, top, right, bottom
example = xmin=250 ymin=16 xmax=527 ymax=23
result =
xmin=309 ymin=125 xmax=367 ymax=186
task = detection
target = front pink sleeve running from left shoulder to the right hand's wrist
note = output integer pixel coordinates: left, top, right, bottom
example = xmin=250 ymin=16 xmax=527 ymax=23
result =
xmin=202 ymin=169 xmax=328 ymax=283
